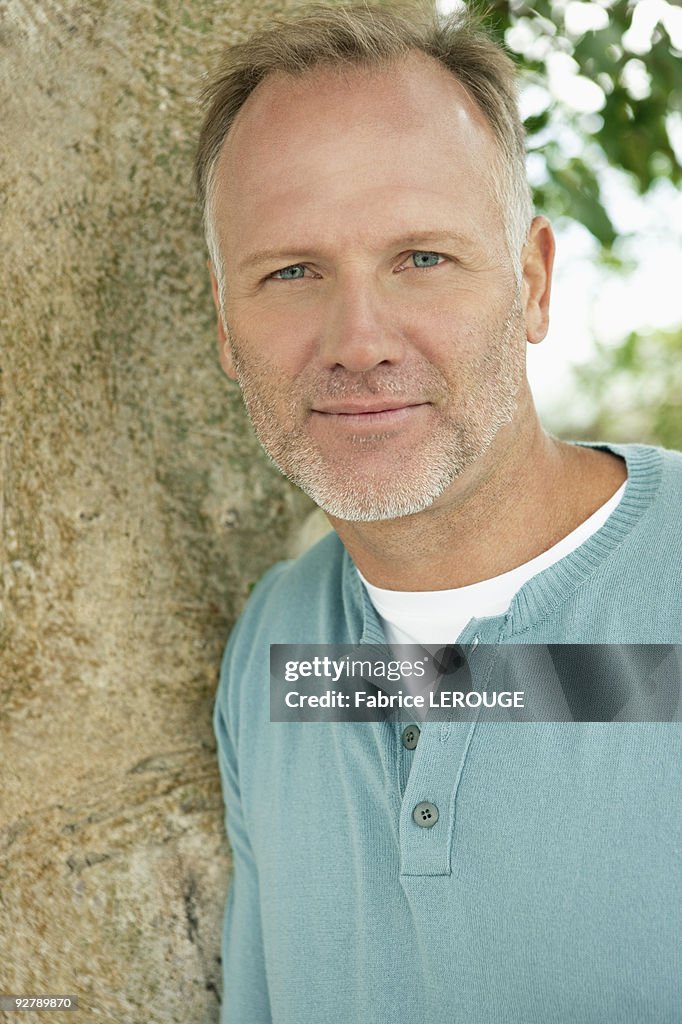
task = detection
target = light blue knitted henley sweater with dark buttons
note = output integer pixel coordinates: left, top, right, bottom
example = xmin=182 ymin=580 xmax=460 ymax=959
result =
xmin=214 ymin=445 xmax=682 ymax=1024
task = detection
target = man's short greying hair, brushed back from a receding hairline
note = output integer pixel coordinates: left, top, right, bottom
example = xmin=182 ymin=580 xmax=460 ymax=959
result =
xmin=195 ymin=3 xmax=532 ymax=309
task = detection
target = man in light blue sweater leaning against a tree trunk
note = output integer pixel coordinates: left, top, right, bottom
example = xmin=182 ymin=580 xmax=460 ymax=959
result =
xmin=192 ymin=6 xmax=682 ymax=1024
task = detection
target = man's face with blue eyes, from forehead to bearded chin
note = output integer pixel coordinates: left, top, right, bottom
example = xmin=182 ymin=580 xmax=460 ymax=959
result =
xmin=210 ymin=54 xmax=527 ymax=521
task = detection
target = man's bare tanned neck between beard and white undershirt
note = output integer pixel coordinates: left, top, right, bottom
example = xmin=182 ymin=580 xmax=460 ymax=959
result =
xmin=332 ymin=418 xmax=627 ymax=591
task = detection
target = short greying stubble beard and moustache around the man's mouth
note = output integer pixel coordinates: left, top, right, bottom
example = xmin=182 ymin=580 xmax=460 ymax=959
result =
xmin=226 ymin=292 xmax=525 ymax=522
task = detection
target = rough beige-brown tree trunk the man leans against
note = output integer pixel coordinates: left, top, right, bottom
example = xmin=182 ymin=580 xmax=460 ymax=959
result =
xmin=0 ymin=0 xmax=319 ymax=1024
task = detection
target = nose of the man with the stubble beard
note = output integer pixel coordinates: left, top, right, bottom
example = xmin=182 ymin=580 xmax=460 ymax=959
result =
xmin=319 ymin=280 xmax=404 ymax=373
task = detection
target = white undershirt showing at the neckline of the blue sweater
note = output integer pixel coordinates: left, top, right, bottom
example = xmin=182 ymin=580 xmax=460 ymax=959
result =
xmin=358 ymin=480 xmax=627 ymax=645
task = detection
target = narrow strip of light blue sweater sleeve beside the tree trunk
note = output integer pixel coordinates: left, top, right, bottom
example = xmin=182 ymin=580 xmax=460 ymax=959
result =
xmin=213 ymin=645 xmax=271 ymax=1024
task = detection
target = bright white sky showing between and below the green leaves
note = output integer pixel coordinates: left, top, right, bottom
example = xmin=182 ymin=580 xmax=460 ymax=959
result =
xmin=437 ymin=0 xmax=682 ymax=428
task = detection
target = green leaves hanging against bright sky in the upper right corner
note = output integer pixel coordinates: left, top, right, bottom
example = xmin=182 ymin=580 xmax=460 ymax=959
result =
xmin=485 ymin=0 xmax=682 ymax=243
